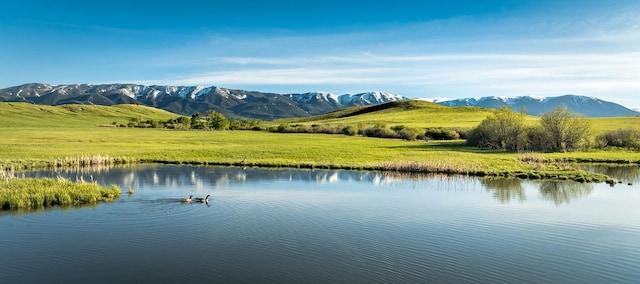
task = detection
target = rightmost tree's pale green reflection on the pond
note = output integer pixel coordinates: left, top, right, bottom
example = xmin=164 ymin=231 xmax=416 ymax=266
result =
xmin=540 ymin=181 xmax=593 ymax=205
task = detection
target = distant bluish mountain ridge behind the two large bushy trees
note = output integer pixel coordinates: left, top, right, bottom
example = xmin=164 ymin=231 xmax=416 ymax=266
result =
xmin=431 ymin=95 xmax=640 ymax=117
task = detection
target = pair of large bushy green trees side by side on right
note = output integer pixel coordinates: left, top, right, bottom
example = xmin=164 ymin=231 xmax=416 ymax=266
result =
xmin=467 ymin=107 xmax=590 ymax=152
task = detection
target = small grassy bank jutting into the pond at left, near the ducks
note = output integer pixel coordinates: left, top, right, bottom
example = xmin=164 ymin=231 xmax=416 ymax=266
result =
xmin=0 ymin=178 xmax=120 ymax=209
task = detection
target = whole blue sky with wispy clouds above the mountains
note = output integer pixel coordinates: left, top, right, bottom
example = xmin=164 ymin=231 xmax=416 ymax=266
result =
xmin=0 ymin=0 xmax=640 ymax=109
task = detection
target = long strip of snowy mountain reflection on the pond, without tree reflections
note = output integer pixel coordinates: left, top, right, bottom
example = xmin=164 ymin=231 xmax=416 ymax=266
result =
xmin=21 ymin=165 xmax=482 ymax=191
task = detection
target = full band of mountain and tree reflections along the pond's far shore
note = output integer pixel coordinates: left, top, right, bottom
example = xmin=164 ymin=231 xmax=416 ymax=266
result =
xmin=18 ymin=164 xmax=640 ymax=205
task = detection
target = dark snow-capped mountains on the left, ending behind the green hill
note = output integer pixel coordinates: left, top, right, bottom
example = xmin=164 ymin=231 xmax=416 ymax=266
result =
xmin=0 ymin=83 xmax=407 ymax=120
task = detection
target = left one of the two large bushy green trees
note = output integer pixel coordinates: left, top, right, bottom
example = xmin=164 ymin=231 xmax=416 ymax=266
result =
xmin=467 ymin=106 xmax=526 ymax=150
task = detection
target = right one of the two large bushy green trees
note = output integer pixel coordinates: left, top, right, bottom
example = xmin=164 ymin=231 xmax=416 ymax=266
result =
xmin=540 ymin=106 xmax=591 ymax=151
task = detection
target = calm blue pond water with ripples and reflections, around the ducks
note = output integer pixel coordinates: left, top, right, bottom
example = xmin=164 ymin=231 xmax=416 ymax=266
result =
xmin=0 ymin=165 xmax=640 ymax=283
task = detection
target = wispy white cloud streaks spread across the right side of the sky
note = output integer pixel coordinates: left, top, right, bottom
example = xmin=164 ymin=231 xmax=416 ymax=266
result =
xmin=135 ymin=9 xmax=640 ymax=108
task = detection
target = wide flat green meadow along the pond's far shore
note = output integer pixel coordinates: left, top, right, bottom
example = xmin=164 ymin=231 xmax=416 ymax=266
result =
xmin=0 ymin=128 xmax=624 ymax=181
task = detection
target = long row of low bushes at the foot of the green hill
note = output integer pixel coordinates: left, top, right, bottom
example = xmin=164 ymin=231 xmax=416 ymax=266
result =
xmin=267 ymin=124 xmax=467 ymax=141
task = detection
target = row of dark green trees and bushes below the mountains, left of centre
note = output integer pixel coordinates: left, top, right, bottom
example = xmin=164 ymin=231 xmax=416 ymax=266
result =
xmin=113 ymin=111 xmax=264 ymax=130
